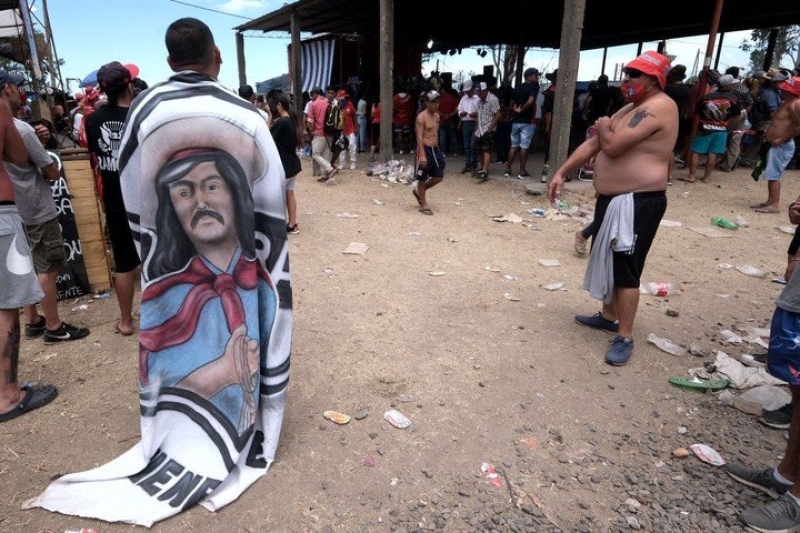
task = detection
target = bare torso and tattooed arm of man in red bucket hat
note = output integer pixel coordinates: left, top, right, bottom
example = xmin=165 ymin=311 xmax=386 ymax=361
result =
xmin=594 ymin=92 xmax=678 ymax=195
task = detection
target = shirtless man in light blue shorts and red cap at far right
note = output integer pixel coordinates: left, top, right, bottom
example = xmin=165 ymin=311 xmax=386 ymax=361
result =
xmin=750 ymin=76 xmax=800 ymax=213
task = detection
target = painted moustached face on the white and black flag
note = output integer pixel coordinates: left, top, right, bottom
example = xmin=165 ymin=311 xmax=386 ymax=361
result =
xmin=169 ymin=161 xmax=237 ymax=247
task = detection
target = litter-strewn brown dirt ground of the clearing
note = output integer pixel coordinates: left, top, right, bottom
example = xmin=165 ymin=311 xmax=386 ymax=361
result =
xmin=0 ymin=151 xmax=800 ymax=533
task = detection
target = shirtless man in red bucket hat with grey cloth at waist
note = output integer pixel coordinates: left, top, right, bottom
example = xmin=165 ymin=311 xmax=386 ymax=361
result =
xmin=547 ymin=51 xmax=678 ymax=365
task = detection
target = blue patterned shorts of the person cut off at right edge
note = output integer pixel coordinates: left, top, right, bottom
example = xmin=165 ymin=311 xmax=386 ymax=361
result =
xmin=767 ymin=307 xmax=800 ymax=385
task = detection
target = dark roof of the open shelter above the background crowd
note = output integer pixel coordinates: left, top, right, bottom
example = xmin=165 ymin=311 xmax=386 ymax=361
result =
xmin=236 ymin=0 xmax=800 ymax=51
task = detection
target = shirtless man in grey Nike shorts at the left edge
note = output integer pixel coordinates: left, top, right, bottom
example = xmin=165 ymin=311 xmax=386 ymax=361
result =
xmin=0 ymin=83 xmax=58 ymax=422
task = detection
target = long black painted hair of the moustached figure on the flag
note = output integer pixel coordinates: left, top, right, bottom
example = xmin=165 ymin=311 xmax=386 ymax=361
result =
xmin=148 ymin=148 xmax=255 ymax=279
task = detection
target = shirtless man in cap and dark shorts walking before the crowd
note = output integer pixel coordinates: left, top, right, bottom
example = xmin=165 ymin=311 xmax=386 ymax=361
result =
xmin=411 ymin=91 xmax=444 ymax=215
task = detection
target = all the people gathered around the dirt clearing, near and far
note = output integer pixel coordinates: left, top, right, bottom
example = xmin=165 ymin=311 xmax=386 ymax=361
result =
xmin=0 ymin=18 xmax=800 ymax=531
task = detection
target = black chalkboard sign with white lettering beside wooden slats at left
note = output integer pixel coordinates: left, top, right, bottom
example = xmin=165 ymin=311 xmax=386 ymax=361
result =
xmin=48 ymin=152 xmax=91 ymax=300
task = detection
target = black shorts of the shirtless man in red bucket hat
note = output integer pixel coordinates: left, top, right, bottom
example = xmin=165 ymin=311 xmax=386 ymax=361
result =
xmin=592 ymin=191 xmax=667 ymax=289
